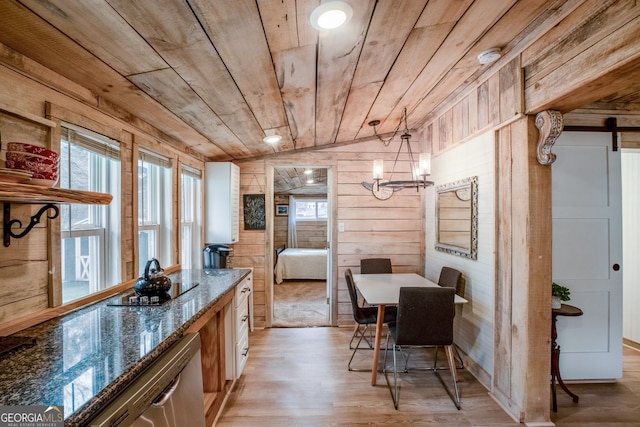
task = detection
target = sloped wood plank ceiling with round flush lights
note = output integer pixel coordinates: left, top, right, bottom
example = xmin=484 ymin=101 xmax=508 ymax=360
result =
xmin=0 ymin=0 xmax=576 ymax=161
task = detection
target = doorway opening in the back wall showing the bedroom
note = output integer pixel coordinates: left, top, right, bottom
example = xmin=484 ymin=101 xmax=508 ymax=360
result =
xmin=271 ymin=165 xmax=332 ymax=327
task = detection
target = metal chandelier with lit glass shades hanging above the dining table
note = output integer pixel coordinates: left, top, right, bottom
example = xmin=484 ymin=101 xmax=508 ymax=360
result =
xmin=362 ymin=108 xmax=433 ymax=199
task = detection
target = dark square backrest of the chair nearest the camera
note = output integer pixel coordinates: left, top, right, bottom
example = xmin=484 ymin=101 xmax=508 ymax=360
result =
xmin=393 ymin=287 xmax=455 ymax=345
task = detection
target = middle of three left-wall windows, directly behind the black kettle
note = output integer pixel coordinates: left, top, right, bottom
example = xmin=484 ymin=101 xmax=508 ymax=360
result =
xmin=138 ymin=150 xmax=174 ymax=275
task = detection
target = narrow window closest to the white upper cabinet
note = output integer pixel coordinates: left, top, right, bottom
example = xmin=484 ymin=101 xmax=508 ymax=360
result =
xmin=180 ymin=166 xmax=202 ymax=268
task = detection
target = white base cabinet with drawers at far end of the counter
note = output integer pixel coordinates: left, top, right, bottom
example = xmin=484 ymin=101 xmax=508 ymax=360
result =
xmin=224 ymin=273 xmax=253 ymax=380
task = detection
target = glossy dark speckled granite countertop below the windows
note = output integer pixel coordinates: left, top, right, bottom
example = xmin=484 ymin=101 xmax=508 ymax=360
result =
xmin=0 ymin=269 xmax=251 ymax=426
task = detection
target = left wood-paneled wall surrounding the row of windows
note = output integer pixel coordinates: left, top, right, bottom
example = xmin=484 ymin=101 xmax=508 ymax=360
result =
xmin=0 ymin=58 xmax=203 ymax=331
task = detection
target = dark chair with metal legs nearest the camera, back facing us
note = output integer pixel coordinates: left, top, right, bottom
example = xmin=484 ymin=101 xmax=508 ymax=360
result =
xmin=384 ymin=287 xmax=460 ymax=409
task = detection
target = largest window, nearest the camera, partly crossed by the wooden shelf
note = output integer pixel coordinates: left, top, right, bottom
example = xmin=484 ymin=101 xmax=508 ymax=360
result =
xmin=60 ymin=125 xmax=122 ymax=303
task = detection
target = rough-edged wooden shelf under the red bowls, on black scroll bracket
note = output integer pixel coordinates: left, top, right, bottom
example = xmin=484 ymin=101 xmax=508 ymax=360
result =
xmin=0 ymin=182 xmax=113 ymax=205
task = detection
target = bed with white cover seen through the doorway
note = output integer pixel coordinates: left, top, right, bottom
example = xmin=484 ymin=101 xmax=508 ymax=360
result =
xmin=274 ymin=248 xmax=327 ymax=284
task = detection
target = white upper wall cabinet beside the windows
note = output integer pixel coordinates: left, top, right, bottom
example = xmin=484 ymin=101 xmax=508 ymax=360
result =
xmin=204 ymin=162 xmax=240 ymax=244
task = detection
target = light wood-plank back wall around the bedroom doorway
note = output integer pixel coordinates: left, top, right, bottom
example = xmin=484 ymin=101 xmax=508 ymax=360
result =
xmin=234 ymin=140 xmax=424 ymax=327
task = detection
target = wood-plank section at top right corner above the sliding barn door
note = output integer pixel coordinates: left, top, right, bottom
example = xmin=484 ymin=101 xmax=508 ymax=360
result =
xmin=522 ymin=0 xmax=640 ymax=112
